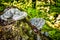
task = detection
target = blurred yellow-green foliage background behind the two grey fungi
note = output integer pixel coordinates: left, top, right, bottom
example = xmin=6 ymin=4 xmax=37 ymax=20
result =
xmin=0 ymin=0 xmax=60 ymax=40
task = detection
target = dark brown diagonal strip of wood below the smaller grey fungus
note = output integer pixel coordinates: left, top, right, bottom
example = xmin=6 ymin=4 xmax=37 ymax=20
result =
xmin=25 ymin=18 xmax=49 ymax=40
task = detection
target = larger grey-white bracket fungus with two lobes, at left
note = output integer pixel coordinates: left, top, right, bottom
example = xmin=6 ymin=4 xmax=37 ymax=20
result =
xmin=0 ymin=8 xmax=27 ymax=25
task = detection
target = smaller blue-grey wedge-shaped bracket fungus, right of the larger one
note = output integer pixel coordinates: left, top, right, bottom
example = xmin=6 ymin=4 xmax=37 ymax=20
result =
xmin=30 ymin=18 xmax=45 ymax=30
